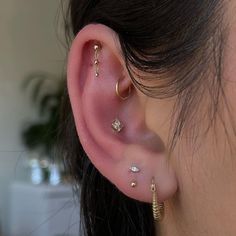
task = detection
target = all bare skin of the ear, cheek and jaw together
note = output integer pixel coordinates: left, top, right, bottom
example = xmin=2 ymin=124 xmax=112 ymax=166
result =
xmin=68 ymin=1 xmax=236 ymax=236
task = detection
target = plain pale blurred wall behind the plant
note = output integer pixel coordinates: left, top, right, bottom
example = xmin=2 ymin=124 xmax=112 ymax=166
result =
xmin=0 ymin=0 xmax=65 ymax=234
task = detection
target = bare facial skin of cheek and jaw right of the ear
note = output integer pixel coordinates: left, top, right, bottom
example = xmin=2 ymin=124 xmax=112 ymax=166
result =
xmin=159 ymin=2 xmax=236 ymax=236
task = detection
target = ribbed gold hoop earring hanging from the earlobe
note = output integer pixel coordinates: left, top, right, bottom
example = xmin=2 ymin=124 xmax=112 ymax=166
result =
xmin=151 ymin=178 xmax=165 ymax=222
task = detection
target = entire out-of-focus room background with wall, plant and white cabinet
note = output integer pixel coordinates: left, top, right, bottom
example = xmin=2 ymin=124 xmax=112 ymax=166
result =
xmin=0 ymin=0 xmax=79 ymax=236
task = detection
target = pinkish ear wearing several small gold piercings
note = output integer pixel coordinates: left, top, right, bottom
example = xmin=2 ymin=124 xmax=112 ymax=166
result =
xmin=68 ymin=24 xmax=177 ymax=202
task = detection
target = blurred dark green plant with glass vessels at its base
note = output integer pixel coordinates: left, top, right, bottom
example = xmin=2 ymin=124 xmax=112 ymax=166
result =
xmin=22 ymin=72 xmax=65 ymax=183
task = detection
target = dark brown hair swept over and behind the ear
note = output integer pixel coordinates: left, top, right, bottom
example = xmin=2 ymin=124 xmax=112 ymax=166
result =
xmin=57 ymin=0 xmax=225 ymax=236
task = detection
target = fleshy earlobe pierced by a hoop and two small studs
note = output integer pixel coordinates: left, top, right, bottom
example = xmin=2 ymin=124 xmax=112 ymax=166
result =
xmin=120 ymin=144 xmax=178 ymax=202
